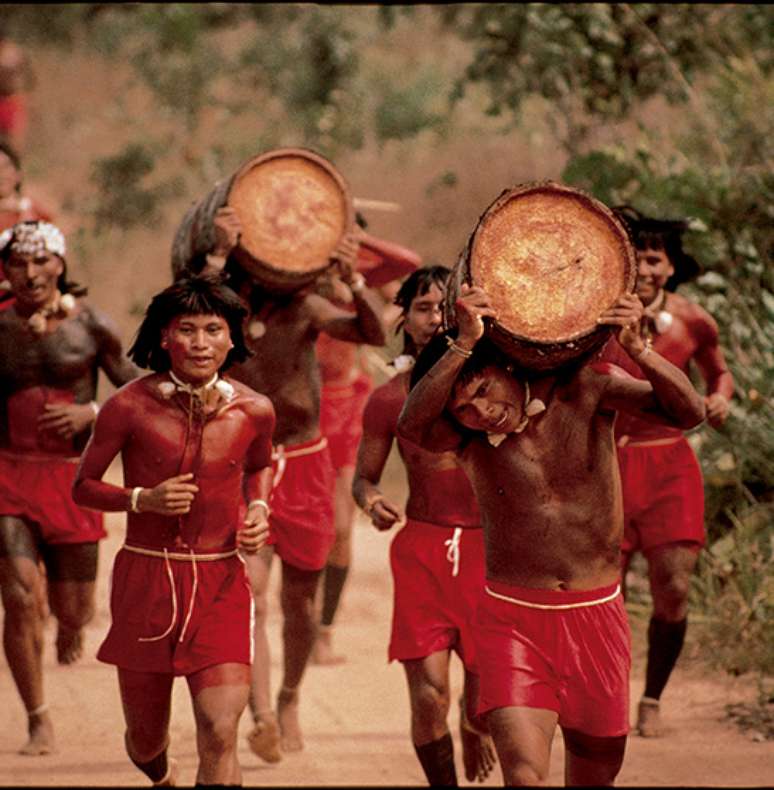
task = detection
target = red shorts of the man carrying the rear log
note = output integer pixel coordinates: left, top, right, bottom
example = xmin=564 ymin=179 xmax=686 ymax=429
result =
xmin=268 ymin=437 xmax=336 ymax=571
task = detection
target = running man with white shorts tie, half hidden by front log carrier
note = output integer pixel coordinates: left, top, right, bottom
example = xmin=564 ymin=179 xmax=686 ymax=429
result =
xmin=352 ymin=266 xmax=495 ymax=786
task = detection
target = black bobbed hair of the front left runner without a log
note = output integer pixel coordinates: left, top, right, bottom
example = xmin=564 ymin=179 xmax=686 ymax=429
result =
xmin=127 ymin=275 xmax=252 ymax=373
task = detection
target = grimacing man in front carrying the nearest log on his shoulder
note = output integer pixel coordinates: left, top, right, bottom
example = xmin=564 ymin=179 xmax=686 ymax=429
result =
xmin=398 ymin=284 xmax=704 ymax=785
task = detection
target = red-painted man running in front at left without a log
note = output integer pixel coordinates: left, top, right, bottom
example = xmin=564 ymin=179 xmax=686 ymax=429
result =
xmin=73 ymin=277 xmax=274 ymax=785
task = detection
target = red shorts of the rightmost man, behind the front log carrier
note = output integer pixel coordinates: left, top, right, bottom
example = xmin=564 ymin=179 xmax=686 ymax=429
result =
xmin=618 ymin=438 xmax=705 ymax=553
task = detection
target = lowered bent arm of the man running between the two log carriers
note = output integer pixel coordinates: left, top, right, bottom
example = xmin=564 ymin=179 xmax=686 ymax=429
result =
xmin=352 ymin=392 xmax=402 ymax=530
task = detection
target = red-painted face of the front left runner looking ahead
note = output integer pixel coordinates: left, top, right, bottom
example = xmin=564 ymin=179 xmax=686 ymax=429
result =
xmin=161 ymin=315 xmax=234 ymax=384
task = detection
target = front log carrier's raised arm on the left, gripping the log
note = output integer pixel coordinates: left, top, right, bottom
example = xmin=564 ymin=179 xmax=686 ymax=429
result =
xmin=398 ymin=284 xmax=496 ymax=452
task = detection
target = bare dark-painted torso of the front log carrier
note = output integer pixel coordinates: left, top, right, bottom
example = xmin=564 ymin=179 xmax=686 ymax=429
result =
xmin=460 ymin=368 xmax=623 ymax=589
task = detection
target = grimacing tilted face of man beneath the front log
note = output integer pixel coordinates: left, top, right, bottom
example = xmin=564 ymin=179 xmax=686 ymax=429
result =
xmin=448 ymin=365 xmax=523 ymax=433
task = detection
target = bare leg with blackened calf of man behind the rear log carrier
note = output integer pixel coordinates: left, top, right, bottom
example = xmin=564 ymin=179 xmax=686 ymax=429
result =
xmin=312 ymin=466 xmax=355 ymax=665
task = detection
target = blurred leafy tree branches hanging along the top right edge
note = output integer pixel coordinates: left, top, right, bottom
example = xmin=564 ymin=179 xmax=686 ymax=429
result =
xmin=438 ymin=3 xmax=774 ymax=153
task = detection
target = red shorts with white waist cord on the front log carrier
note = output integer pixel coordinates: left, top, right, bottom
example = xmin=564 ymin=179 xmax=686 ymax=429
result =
xmin=475 ymin=581 xmax=631 ymax=738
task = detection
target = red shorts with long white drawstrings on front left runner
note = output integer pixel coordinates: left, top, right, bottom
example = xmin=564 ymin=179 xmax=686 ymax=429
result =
xmin=97 ymin=547 xmax=253 ymax=675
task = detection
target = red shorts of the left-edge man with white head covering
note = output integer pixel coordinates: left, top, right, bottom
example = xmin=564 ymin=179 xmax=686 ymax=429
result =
xmin=0 ymin=450 xmax=107 ymax=545
